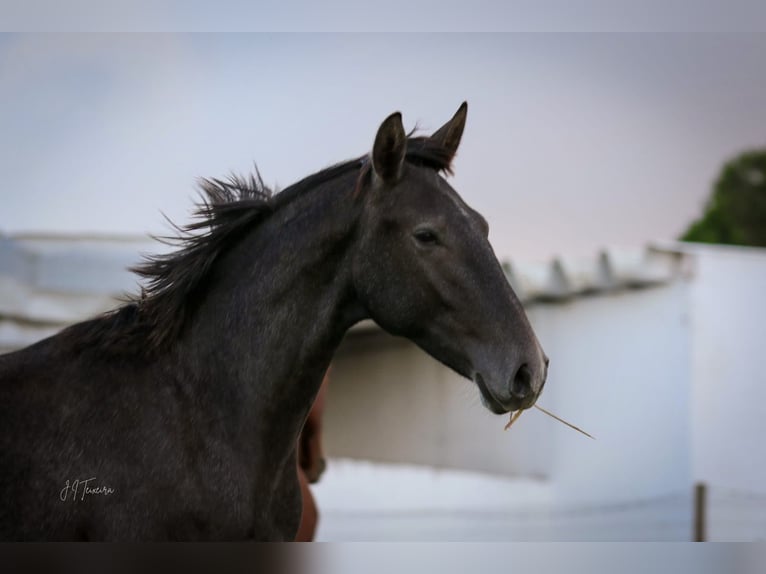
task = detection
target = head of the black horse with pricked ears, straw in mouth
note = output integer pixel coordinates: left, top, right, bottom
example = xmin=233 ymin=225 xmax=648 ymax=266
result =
xmin=353 ymin=103 xmax=548 ymax=414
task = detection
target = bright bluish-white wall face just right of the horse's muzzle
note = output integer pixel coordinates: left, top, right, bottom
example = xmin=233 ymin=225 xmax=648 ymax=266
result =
xmin=530 ymin=280 xmax=691 ymax=500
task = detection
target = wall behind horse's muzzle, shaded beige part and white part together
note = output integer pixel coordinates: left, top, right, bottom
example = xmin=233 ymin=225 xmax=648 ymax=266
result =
xmin=325 ymin=281 xmax=691 ymax=508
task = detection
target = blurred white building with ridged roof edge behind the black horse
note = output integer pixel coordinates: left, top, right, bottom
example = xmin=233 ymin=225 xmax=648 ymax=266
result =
xmin=0 ymin=236 xmax=766 ymax=540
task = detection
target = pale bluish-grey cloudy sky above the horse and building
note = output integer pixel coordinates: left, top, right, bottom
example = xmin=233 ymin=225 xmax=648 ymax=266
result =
xmin=0 ymin=33 xmax=766 ymax=260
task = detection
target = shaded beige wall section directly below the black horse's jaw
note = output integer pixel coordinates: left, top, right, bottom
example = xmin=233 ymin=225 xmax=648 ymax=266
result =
xmin=324 ymin=332 xmax=551 ymax=477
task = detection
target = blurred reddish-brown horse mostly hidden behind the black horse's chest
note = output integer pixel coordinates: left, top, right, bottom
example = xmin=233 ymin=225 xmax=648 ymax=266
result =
xmin=295 ymin=375 xmax=328 ymax=542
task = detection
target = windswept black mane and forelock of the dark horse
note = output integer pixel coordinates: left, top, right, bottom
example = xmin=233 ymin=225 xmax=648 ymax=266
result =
xmin=65 ymin=137 xmax=452 ymax=354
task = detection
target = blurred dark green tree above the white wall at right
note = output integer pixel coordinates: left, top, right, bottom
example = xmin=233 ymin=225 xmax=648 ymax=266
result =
xmin=680 ymin=149 xmax=766 ymax=247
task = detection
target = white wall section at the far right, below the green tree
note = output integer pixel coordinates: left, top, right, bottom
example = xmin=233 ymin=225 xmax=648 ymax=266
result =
xmin=691 ymin=247 xmax=766 ymax=492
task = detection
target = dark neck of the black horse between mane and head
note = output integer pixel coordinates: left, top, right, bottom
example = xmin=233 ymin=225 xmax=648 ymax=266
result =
xmin=172 ymin=173 xmax=364 ymax=462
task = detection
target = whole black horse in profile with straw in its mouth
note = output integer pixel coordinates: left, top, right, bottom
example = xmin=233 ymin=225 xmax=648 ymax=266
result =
xmin=0 ymin=102 xmax=548 ymax=541
